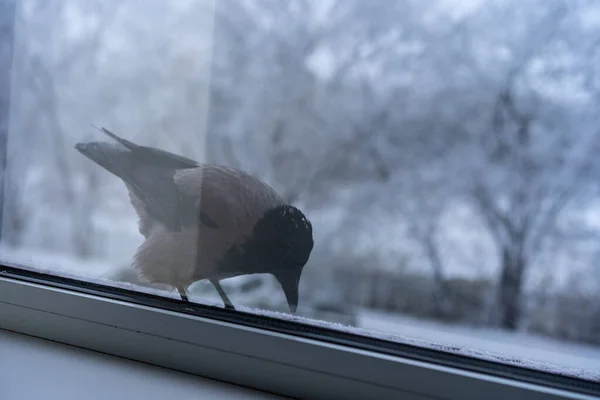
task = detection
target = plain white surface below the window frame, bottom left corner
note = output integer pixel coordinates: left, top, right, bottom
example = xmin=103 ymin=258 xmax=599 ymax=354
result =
xmin=0 ymin=329 xmax=283 ymax=400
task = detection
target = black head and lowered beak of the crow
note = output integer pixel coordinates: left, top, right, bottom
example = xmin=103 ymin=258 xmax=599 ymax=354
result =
xmin=244 ymin=205 xmax=314 ymax=312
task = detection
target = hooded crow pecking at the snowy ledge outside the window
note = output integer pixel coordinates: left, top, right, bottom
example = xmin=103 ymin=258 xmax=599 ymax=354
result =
xmin=75 ymin=127 xmax=314 ymax=314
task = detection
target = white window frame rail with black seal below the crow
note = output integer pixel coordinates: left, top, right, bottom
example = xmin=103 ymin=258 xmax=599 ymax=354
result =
xmin=0 ymin=267 xmax=600 ymax=400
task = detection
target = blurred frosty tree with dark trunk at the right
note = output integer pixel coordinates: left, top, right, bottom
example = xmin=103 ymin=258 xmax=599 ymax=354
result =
xmin=396 ymin=1 xmax=600 ymax=329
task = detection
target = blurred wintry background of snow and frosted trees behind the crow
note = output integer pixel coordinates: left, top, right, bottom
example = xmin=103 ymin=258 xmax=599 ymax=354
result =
xmin=0 ymin=0 xmax=600 ymax=374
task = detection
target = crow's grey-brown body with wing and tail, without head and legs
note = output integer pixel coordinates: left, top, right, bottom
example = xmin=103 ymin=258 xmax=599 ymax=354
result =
xmin=76 ymin=128 xmax=283 ymax=287
